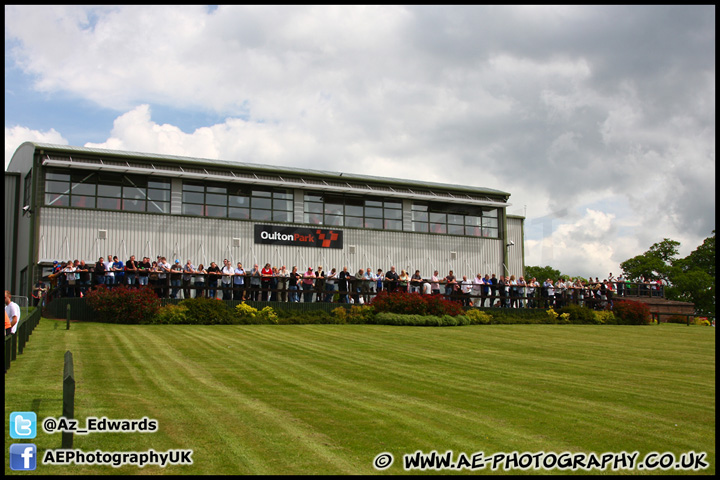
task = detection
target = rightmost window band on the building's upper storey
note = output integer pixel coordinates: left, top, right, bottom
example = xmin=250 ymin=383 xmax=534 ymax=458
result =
xmin=411 ymin=202 xmax=500 ymax=238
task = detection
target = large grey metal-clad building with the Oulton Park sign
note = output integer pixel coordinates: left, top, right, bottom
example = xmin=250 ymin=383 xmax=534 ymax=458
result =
xmin=5 ymin=142 xmax=524 ymax=296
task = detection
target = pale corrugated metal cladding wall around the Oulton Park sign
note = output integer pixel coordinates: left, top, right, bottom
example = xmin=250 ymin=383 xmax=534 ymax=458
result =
xmin=37 ymin=208 xmax=522 ymax=277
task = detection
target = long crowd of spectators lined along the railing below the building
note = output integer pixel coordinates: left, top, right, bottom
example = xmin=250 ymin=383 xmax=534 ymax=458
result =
xmin=42 ymin=255 xmax=662 ymax=308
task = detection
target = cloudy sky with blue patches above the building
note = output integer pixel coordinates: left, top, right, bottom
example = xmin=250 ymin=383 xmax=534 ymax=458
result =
xmin=5 ymin=5 xmax=715 ymax=278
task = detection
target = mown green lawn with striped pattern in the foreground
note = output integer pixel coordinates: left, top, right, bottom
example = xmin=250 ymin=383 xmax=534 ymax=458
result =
xmin=5 ymin=319 xmax=715 ymax=474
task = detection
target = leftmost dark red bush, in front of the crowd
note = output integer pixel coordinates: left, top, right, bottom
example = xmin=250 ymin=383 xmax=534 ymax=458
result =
xmin=85 ymin=285 xmax=160 ymax=324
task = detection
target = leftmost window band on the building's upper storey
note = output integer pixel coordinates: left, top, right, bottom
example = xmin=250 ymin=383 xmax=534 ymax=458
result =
xmin=45 ymin=169 xmax=170 ymax=214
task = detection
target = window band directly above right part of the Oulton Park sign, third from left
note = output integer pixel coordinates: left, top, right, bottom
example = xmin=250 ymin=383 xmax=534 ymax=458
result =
xmin=303 ymin=193 xmax=402 ymax=230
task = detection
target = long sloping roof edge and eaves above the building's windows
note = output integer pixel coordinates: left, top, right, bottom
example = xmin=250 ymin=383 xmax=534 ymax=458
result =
xmin=22 ymin=142 xmax=510 ymax=206
